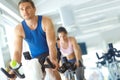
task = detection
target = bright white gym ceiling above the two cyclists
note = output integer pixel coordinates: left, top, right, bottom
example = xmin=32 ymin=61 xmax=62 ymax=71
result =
xmin=0 ymin=0 xmax=120 ymax=47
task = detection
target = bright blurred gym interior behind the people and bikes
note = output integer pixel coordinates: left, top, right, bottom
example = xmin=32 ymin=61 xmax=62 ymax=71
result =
xmin=0 ymin=0 xmax=120 ymax=80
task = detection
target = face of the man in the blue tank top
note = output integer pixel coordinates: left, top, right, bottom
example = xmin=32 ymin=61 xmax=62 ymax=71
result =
xmin=19 ymin=2 xmax=36 ymax=20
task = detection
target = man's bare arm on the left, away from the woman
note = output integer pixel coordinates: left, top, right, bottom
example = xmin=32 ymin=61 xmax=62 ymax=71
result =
xmin=13 ymin=24 xmax=23 ymax=63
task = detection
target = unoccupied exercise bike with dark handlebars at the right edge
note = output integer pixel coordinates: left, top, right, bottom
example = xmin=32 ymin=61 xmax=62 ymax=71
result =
xmin=96 ymin=43 xmax=120 ymax=80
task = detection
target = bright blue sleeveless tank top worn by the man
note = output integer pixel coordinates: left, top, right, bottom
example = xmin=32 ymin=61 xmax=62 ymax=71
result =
xmin=22 ymin=16 xmax=49 ymax=58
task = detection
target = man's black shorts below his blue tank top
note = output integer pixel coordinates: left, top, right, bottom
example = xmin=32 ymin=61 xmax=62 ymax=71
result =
xmin=37 ymin=53 xmax=49 ymax=72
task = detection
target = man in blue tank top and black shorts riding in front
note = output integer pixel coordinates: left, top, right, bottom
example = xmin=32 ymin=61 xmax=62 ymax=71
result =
xmin=9 ymin=0 xmax=61 ymax=80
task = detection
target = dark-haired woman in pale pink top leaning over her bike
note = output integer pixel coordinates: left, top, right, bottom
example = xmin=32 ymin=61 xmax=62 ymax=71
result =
xmin=57 ymin=27 xmax=84 ymax=80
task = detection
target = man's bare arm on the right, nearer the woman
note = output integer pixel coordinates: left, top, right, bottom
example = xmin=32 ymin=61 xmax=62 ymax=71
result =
xmin=42 ymin=16 xmax=58 ymax=67
